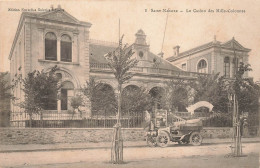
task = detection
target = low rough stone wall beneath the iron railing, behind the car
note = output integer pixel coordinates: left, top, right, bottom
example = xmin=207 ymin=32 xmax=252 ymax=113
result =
xmin=0 ymin=127 xmax=233 ymax=145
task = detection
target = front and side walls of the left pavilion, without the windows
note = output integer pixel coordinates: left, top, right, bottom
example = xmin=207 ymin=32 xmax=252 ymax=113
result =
xmin=10 ymin=14 xmax=90 ymax=118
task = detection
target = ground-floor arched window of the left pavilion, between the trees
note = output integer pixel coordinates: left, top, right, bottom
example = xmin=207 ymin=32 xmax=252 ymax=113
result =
xmin=61 ymin=81 xmax=74 ymax=110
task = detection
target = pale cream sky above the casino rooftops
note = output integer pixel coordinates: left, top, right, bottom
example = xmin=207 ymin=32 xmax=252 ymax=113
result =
xmin=0 ymin=0 xmax=260 ymax=81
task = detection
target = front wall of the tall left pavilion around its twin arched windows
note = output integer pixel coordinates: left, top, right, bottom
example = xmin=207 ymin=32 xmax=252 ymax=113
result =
xmin=26 ymin=19 xmax=89 ymax=87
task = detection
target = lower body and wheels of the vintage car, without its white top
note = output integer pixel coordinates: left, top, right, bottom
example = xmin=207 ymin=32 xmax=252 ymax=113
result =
xmin=146 ymin=119 xmax=202 ymax=147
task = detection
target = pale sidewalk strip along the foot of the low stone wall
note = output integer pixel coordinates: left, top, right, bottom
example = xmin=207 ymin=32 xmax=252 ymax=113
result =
xmin=0 ymin=137 xmax=260 ymax=153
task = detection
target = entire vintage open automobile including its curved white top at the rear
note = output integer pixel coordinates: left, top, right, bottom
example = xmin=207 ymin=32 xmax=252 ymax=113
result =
xmin=146 ymin=101 xmax=213 ymax=147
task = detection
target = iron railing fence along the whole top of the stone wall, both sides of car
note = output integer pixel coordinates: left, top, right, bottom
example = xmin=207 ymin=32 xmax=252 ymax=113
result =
xmin=10 ymin=111 xmax=258 ymax=128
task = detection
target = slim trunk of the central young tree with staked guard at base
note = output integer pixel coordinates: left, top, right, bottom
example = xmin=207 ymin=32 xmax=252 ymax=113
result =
xmin=111 ymin=84 xmax=123 ymax=164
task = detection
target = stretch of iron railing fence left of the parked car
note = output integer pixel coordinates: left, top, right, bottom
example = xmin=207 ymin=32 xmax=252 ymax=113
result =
xmin=10 ymin=113 xmax=145 ymax=128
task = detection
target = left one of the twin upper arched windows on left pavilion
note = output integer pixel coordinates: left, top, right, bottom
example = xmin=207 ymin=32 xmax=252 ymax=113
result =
xmin=45 ymin=32 xmax=57 ymax=61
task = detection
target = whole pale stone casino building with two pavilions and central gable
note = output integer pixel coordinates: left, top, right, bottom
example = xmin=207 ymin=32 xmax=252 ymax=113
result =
xmin=9 ymin=7 xmax=250 ymax=126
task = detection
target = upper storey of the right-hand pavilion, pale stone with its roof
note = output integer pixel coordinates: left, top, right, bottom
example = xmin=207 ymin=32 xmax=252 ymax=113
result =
xmin=167 ymin=38 xmax=251 ymax=78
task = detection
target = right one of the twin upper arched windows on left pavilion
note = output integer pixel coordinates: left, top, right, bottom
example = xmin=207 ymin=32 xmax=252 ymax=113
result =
xmin=60 ymin=34 xmax=72 ymax=62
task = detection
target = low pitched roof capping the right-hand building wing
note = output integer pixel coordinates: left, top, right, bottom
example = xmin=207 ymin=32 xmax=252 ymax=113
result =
xmin=166 ymin=37 xmax=251 ymax=62
